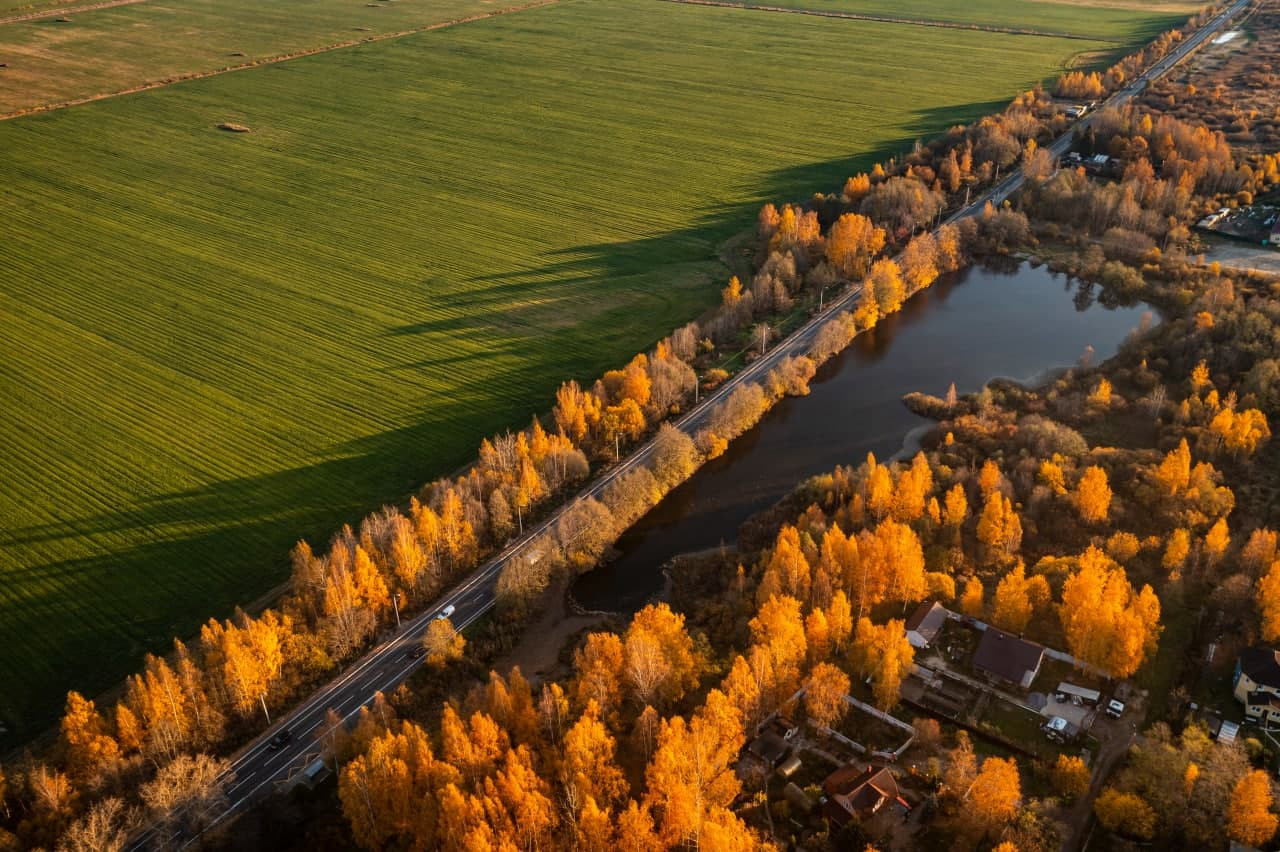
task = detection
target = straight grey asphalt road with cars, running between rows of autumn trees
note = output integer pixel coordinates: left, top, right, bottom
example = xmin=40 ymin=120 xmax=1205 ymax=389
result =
xmin=129 ymin=0 xmax=1249 ymax=849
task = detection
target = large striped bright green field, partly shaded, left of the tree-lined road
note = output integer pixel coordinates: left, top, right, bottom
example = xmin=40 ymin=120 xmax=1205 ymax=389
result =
xmin=0 ymin=0 xmax=1146 ymax=729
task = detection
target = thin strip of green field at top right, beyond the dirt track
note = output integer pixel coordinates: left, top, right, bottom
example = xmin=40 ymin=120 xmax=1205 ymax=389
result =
xmin=742 ymin=0 xmax=1206 ymax=47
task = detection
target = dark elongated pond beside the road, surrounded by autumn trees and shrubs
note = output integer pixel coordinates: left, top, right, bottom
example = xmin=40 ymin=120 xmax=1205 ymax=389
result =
xmin=573 ymin=258 xmax=1149 ymax=611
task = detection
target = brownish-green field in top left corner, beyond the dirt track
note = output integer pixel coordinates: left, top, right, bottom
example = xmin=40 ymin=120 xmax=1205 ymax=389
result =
xmin=0 ymin=0 xmax=524 ymax=114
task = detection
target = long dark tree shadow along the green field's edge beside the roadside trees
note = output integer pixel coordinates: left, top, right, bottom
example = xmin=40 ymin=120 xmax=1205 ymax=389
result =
xmin=0 ymin=95 xmax=1018 ymax=747
